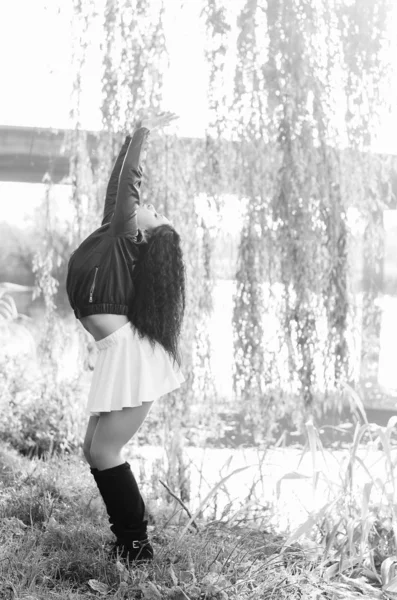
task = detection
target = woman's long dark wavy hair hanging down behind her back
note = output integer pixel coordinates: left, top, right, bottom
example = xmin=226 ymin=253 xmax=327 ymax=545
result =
xmin=128 ymin=224 xmax=186 ymax=366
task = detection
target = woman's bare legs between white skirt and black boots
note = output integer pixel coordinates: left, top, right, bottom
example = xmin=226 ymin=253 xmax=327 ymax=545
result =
xmin=90 ymin=402 xmax=153 ymax=471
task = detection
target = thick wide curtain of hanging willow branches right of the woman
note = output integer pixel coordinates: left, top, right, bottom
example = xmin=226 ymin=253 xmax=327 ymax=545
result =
xmin=226 ymin=0 xmax=390 ymax=434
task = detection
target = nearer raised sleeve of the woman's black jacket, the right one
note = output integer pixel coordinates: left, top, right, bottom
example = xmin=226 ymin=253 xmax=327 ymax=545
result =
xmin=111 ymin=127 xmax=150 ymax=236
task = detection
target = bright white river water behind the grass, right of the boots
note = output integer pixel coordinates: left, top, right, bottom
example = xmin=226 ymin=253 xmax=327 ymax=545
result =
xmin=126 ymin=442 xmax=397 ymax=533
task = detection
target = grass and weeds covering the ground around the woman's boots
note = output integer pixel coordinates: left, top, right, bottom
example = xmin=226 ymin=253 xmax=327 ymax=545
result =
xmin=0 ymin=428 xmax=397 ymax=600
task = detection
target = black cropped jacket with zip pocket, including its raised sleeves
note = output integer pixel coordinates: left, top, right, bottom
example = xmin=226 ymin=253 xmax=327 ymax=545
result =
xmin=66 ymin=127 xmax=150 ymax=319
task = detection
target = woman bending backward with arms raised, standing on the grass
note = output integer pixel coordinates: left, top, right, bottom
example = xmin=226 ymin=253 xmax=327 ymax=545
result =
xmin=66 ymin=113 xmax=185 ymax=561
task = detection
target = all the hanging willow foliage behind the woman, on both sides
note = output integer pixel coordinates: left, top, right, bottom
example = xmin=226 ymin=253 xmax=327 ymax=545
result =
xmin=32 ymin=0 xmax=395 ymax=446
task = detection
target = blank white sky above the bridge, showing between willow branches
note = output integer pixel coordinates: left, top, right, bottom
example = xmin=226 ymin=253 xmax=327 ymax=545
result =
xmin=0 ymin=0 xmax=397 ymax=154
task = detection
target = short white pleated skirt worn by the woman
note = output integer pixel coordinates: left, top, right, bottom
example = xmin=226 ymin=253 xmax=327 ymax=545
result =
xmin=87 ymin=322 xmax=185 ymax=416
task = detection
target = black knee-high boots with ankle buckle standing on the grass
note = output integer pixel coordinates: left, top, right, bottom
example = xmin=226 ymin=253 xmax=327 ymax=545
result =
xmin=91 ymin=462 xmax=153 ymax=561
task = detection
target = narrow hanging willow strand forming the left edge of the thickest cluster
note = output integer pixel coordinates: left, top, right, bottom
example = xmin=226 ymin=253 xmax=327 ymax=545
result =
xmin=230 ymin=1 xmax=279 ymax=436
